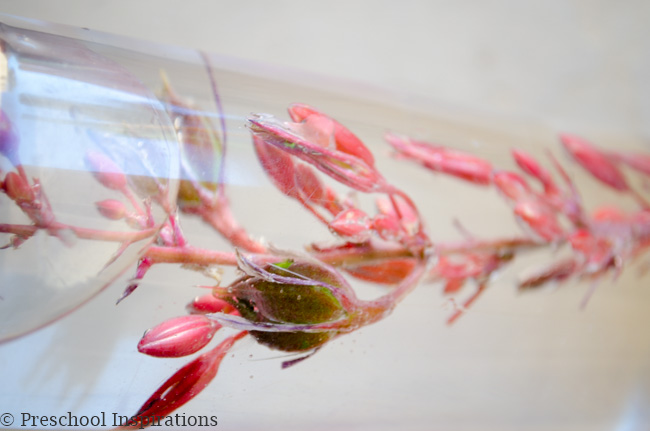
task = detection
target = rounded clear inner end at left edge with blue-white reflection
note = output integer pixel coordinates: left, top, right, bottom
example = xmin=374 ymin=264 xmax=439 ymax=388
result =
xmin=0 ymin=16 xmax=179 ymax=340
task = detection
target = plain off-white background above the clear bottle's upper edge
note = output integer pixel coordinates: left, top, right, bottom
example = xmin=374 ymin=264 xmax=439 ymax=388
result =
xmin=0 ymin=0 xmax=650 ymax=137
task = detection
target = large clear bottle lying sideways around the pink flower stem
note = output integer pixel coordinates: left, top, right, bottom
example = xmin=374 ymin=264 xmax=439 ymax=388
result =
xmin=0 ymin=11 xmax=650 ymax=430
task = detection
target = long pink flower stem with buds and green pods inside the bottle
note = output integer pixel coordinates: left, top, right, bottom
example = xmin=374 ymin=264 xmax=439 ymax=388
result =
xmin=0 ymin=69 xmax=650 ymax=426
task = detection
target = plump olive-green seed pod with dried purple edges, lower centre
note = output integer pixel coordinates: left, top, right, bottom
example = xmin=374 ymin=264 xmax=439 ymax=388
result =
xmin=216 ymin=257 xmax=356 ymax=352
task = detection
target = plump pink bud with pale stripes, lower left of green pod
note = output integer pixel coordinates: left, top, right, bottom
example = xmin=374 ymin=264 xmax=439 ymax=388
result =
xmin=138 ymin=315 xmax=221 ymax=358
